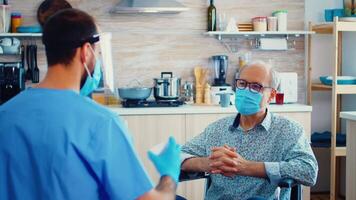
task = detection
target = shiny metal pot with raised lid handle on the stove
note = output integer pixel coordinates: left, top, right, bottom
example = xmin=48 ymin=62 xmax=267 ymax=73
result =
xmin=153 ymin=72 xmax=181 ymax=100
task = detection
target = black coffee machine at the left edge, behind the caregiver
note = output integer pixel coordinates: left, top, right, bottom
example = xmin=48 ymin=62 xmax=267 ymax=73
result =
xmin=0 ymin=62 xmax=25 ymax=105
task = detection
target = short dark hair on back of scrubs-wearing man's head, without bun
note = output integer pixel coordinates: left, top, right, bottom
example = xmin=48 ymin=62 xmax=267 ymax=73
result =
xmin=42 ymin=8 xmax=98 ymax=66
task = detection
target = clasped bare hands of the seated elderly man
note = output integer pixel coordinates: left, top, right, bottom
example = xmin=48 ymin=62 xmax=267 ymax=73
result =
xmin=209 ymin=145 xmax=248 ymax=177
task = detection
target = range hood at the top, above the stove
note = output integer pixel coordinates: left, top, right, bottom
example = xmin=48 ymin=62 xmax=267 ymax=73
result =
xmin=110 ymin=0 xmax=189 ymax=14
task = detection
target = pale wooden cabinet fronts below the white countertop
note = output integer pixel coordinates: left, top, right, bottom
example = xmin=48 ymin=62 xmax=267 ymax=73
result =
xmin=122 ymin=112 xmax=311 ymax=200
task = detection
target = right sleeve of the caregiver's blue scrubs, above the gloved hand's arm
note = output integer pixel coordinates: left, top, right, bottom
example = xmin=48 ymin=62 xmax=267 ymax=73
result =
xmin=85 ymin=117 xmax=153 ymax=199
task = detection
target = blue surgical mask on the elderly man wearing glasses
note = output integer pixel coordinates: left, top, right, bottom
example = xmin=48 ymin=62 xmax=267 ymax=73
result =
xmin=235 ymin=88 xmax=263 ymax=115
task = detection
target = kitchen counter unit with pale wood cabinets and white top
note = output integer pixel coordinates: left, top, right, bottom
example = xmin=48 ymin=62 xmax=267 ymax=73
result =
xmin=115 ymin=104 xmax=312 ymax=199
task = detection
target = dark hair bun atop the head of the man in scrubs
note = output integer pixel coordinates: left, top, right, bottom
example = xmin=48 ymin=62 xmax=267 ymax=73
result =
xmin=37 ymin=0 xmax=72 ymax=27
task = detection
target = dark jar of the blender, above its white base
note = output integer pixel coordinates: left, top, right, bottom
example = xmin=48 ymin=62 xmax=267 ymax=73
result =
xmin=212 ymin=55 xmax=229 ymax=86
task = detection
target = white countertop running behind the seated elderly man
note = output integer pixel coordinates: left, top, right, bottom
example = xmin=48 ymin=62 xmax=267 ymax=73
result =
xmin=108 ymin=104 xmax=312 ymax=116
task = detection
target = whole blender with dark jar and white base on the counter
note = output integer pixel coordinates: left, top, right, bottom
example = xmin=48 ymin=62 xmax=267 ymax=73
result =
xmin=210 ymin=55 xmax=235 ymax=105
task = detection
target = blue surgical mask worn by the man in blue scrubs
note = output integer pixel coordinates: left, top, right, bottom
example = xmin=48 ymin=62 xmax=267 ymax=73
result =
xmin=80 ymin=58 xmax=102 ymax=96
